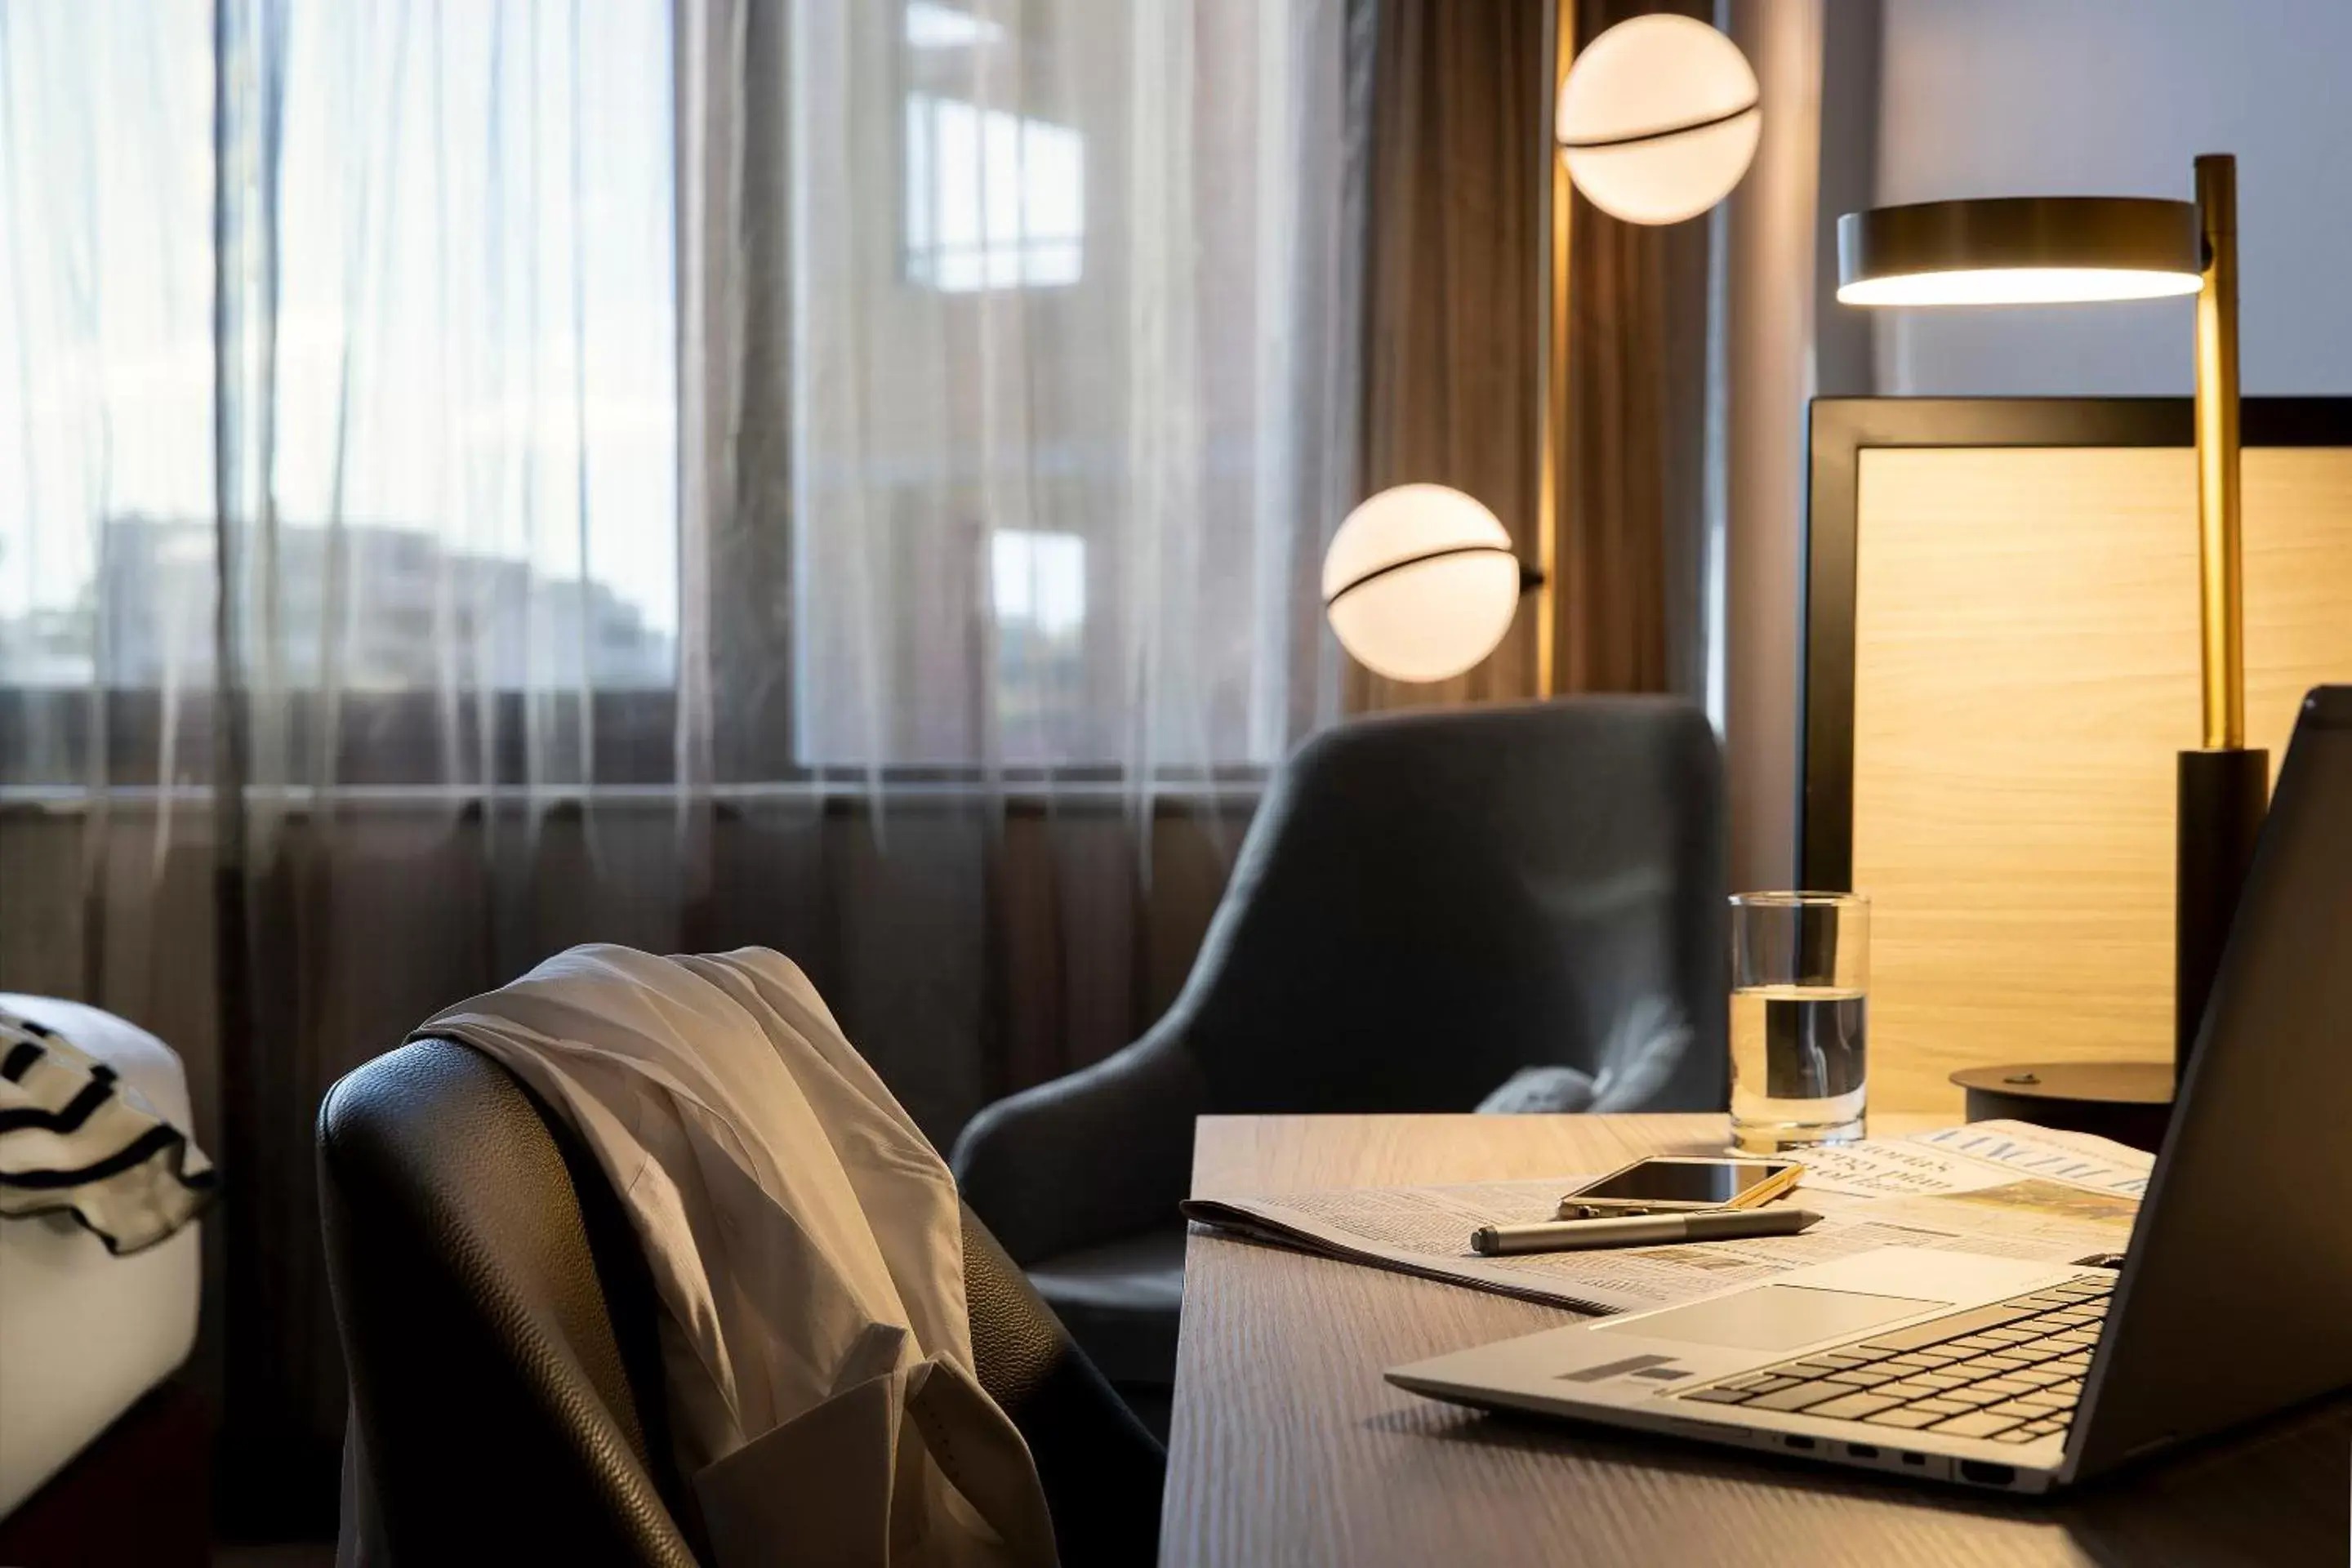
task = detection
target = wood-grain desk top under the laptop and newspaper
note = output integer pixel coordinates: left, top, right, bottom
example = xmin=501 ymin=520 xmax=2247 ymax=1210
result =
xmin=1160 ymin=1116 xmax=2352 ymax=1568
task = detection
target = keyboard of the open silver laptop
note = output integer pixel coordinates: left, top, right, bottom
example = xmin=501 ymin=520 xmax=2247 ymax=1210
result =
xmin=1675 ymin=1276 xmax=2114 ymax=1443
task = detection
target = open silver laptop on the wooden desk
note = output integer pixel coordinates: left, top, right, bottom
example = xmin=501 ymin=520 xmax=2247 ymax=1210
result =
xmin=1388 ymin=687 xmax=2352 ymax=1493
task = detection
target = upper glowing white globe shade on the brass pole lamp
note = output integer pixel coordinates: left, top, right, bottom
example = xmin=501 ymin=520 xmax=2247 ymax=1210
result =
xmin=1557 ymin=14 xmax=1764 ymax=223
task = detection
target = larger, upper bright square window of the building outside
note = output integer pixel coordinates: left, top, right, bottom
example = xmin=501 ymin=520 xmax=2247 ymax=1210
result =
xmin=906 ymin=92 xmax=1087 ymax=294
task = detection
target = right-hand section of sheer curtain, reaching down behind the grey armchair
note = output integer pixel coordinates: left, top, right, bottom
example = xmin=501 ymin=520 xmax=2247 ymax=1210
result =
xmin=679 ymin=0 xmax=1369 ymax=1138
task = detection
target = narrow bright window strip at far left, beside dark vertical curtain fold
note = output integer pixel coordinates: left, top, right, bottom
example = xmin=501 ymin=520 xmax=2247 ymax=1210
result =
xmin=0 ymin=0 xmax=212 ymax=687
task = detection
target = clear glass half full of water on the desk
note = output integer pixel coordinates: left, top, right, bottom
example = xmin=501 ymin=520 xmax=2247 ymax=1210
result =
xmin=1731 ymin=893 xmax=1870 ymax=1154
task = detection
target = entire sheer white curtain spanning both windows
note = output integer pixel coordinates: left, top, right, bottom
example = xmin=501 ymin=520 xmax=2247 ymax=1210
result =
xmin=0 ymin=0 xmax=1362 ymax=1502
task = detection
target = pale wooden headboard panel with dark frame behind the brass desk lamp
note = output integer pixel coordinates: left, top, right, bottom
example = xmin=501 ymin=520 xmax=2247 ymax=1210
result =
xmin=1797 ymin=397 xmax=2352 ymax=1114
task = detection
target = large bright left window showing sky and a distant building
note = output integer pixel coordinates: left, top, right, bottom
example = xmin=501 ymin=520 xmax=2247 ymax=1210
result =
xmin=0 ymin=0 xmax=677 ymax=696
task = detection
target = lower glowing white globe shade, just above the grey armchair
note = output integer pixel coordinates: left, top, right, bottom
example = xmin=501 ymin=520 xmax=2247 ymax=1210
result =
xmin=1324 ymin=484 xmax=1519 ymax=682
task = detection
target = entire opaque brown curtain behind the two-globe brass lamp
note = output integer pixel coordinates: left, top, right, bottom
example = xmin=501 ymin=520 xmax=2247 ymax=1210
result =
xmin=1345 ymin=0 xmax=1710 ymax=710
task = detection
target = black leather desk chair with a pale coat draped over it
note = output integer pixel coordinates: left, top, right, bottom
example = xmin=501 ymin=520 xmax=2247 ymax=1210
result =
xmin=318 ymin=1039 xmax=1165 ymax=1568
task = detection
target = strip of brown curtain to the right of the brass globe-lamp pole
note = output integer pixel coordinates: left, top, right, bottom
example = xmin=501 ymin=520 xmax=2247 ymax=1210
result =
xmin=1555 ymin=0 xmax=1715 ymax=693
